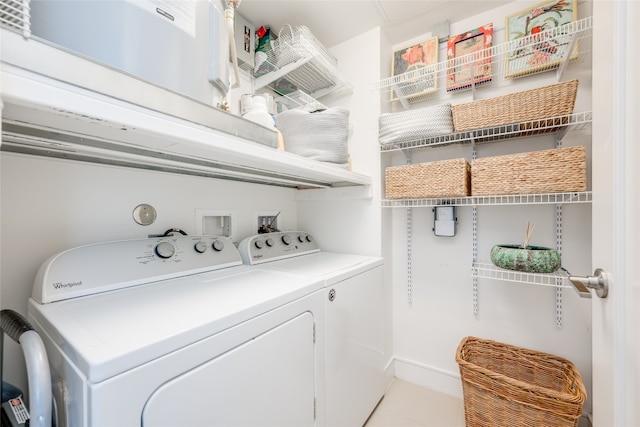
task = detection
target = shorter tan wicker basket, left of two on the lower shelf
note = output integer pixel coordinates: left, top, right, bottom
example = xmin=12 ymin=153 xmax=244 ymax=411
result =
xmin=385 ymin=159 xmax=470 ymax=199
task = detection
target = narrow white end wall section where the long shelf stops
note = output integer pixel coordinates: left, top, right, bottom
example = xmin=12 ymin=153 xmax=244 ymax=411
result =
xmin=298 ymin=28 xmax=381 ymax=256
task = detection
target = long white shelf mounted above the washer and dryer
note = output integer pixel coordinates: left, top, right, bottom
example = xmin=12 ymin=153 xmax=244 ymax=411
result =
xmin=0 ymin=29 xmax=371 ymax=189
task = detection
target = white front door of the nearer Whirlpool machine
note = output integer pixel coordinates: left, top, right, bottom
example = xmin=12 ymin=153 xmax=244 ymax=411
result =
xmin=142 ymin=312 xmax=315 ymax=427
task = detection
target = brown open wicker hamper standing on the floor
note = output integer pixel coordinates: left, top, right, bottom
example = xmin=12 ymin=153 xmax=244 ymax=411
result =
xmin=456 ymin=337 xmax=587 ymax=427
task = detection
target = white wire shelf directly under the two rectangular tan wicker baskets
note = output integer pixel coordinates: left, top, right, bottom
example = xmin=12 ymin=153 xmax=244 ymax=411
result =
xmin=382 ymin=191 xmax=592 ymax=208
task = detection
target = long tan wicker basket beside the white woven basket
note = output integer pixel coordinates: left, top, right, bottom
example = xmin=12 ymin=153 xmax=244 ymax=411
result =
xmin=451 ymin=80 xmax=578 ymax=132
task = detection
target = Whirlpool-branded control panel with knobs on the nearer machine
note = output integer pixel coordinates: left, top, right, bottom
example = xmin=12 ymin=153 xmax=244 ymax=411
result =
xmin=32 ymin=236 xmax=242 ymax=304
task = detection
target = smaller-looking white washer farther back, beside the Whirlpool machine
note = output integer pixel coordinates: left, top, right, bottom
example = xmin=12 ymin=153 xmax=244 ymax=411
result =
xmin=238 ymin=232 xmax=386 ymax=427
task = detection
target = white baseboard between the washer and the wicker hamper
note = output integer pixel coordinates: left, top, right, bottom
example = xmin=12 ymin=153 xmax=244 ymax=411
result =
xmin=393 ymin=357 xmax=462 ymax=399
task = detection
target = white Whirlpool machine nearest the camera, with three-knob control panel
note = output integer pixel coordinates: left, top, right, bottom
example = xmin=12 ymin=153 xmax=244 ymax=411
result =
xmin=28 ymin=236 xmax=324 ymax=427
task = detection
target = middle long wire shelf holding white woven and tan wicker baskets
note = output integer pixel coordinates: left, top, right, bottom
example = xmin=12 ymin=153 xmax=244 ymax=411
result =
xmin=380 ymin=111 xmax=592 ymax=152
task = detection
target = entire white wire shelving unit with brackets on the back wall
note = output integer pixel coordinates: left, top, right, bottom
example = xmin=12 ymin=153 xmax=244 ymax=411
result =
xmin=372 ymin=17 xmax=592 ymax=320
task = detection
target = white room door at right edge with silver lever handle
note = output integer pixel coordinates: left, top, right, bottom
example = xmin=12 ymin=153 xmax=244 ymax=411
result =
xmin=582 ymin=1 xmax=640 ymax=426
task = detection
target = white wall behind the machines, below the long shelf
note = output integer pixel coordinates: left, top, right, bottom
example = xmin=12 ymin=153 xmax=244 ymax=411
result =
xmin=0 ymin=153 xmax=298 ymax=390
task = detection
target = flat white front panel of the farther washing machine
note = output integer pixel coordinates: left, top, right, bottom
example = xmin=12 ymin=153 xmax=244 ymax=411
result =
xmin=325 ymin=266 xmax=385 ymax=427
